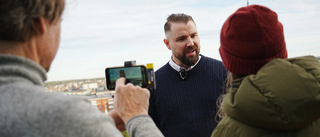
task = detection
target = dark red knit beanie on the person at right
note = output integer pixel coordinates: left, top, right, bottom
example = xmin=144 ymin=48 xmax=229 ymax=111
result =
xmin=219 ymin=5 xmax=287 ymax=75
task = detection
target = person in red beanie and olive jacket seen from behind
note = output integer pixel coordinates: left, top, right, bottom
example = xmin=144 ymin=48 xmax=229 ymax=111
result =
xmin=212 ymin=5 xmax=320 ymax=137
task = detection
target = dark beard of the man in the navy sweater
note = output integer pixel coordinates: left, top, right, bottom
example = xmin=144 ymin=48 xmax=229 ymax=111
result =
xmin=176 ymin=47 xmax=199 ymax=66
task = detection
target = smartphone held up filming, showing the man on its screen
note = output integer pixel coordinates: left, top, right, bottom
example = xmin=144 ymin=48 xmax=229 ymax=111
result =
xmin=105 ymin=65 xmax=148 ymax=90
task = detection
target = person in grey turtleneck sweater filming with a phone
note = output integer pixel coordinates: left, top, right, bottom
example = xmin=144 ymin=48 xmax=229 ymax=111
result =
xmin=0 ymin=0 xmax=163 ymax=137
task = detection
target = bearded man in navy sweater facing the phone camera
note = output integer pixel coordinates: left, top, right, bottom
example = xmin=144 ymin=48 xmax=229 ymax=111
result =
xmin=149 ymin=13 xmax=227 ymax=137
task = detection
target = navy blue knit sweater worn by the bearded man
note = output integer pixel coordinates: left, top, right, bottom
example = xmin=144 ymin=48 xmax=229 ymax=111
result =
xmin=149 ymin=55 xmax=227 ymax=137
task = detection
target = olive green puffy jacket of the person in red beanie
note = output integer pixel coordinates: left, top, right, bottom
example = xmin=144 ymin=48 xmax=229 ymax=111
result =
xmin=212 ymin=56 xmax=320 ymax=137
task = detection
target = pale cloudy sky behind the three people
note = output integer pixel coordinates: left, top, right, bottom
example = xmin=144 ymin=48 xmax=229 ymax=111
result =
xmin=47 ymin=0 xmax=320 ymax=81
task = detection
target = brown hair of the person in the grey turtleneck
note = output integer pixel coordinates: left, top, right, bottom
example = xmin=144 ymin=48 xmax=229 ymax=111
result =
xmin=0 ymin=0 xmax=65 ymax=42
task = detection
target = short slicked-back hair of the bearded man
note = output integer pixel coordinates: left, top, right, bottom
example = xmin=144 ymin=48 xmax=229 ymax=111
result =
xmin=164 ymin=13 xmax=196 ymax=33
